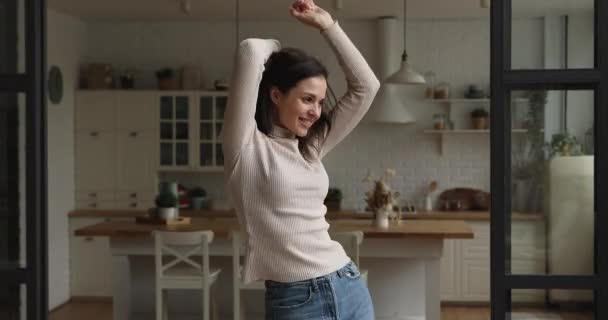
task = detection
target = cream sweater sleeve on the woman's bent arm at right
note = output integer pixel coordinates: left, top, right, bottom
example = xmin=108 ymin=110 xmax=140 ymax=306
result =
xmin=319 ymin=21 xmax=380 ymax=158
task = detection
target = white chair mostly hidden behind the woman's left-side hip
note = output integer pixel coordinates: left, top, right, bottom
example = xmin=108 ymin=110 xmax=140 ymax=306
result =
xmin=230 ymin=231 xmax=266 ymax=320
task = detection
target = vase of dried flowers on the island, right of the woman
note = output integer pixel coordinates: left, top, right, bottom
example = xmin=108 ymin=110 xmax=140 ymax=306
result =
xmin=363 ymin=169 xmax=400 ymax=229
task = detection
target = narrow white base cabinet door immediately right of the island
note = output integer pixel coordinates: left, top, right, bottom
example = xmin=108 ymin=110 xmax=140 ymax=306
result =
xmin=440 ymin=240 xmax=460 ymax=301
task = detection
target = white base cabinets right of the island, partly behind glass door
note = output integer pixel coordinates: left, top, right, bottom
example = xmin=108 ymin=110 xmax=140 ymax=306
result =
xmin=441 ymin=220 xmax=546 ymax=302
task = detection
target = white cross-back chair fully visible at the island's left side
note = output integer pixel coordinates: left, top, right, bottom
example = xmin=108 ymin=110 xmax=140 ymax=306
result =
xmin=154 ymin=231 xmax=221 ymax=320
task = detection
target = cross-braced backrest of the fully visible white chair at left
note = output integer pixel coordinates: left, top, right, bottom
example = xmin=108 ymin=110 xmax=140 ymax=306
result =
xmin=154 ymin=230 xmax=213 ymax=279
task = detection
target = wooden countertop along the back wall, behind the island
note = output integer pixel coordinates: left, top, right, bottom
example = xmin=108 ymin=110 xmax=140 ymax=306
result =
xmin=68 ymin=209 xmax=543 ymax=221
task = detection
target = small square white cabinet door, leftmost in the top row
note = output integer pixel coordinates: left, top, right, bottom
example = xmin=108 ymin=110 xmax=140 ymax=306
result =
xmin=74 ymin=91 xmax=118 ymax=131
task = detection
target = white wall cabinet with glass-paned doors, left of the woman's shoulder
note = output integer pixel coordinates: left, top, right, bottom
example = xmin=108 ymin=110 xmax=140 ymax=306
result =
xmin=159 ymin=91 xmax=227 ymax=171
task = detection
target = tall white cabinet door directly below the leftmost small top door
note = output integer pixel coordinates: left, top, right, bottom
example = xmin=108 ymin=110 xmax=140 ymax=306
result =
xmin=75 ymin=131 xmax=116 ymax=190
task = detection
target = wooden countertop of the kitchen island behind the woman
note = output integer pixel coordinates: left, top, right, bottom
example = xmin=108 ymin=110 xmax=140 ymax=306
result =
xmin=75 ymin=217 xmax=473 ymax=239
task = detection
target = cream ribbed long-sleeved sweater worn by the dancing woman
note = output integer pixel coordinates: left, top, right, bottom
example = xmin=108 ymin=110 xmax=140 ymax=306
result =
xmin=222 ymin=22 xmax=380 ymax=283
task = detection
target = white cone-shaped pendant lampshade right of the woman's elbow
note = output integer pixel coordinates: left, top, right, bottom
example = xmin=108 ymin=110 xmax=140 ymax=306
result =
xmin=368 ymin=84 xmax=416 ymax=124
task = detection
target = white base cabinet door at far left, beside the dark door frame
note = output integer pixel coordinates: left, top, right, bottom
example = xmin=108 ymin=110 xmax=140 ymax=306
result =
xmin=70 ymin=218 xmax=112 ymax=297
